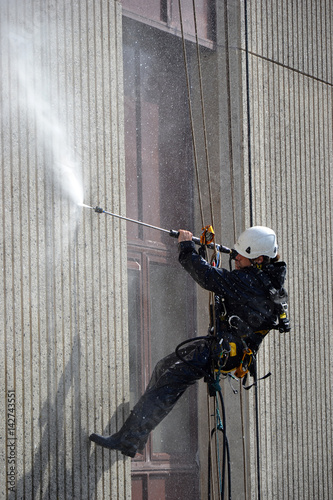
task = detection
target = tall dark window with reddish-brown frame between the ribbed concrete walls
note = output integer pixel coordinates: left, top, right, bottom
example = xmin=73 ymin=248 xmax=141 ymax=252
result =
xmin=123 ymin=18 xmax=198 ymax=500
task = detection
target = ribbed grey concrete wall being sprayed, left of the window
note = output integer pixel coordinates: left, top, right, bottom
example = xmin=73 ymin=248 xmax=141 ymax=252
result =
xmin=0 ymin=0 xmax=131 ymax=499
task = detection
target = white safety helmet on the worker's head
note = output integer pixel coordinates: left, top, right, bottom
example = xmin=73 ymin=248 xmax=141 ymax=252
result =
xmin=235 ymin=226 xmax=278 ymax=259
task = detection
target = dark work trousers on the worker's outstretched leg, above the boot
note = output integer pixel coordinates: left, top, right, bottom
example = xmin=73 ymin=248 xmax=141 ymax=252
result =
xmin=117 ymin=340 xmax=210 ymax=450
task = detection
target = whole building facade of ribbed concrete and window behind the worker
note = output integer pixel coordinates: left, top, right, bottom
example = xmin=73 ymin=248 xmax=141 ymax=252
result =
xmin=0 ymin=0 xmax=333 ymax=500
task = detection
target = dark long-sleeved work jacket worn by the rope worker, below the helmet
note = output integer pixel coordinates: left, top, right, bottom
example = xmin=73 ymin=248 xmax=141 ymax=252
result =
xmin=179 ymin=241 xmax=287 ymax=350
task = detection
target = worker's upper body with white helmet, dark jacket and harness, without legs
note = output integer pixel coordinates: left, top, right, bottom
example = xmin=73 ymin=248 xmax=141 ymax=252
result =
xmin=180 ymin=226 xmax=290 ymax=378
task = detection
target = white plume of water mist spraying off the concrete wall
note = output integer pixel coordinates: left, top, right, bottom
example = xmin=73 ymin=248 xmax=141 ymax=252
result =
xmin=7 ymin=28 xmax=84 ymax=229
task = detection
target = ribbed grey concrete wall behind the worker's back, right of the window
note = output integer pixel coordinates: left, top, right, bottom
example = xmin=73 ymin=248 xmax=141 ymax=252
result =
xmin=243 ymin=0 xmax=333 ymax=499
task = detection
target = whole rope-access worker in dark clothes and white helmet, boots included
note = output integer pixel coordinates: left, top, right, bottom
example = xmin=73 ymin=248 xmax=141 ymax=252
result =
xmin=90 ymin=226 xmax=290 ymax=457
